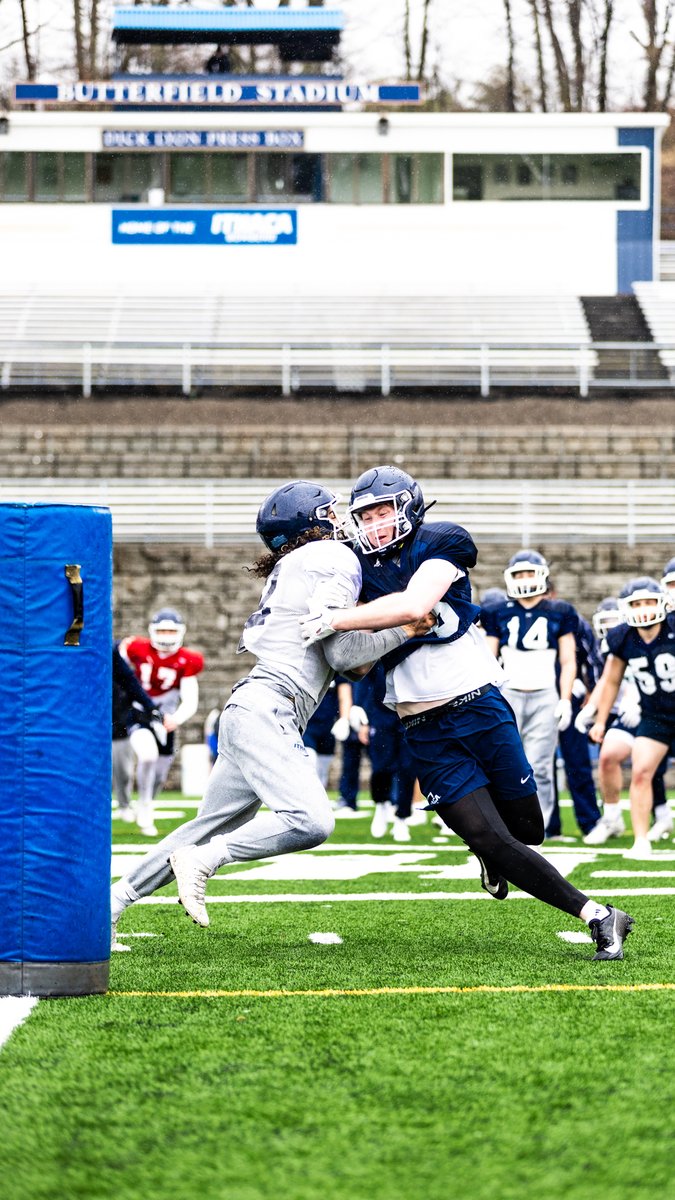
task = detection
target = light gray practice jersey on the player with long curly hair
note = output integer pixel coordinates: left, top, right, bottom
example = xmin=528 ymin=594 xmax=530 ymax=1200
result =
xmin=234 ymin=540 xmax=406 ymax=728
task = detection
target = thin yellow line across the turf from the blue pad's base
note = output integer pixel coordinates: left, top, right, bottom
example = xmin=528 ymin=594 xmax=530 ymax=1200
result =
xmin=108 ymin=983 xmax=675 ymax=1000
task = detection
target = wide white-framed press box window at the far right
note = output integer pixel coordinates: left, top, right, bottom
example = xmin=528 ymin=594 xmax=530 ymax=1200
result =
xmin=453 ymin=151 xmax=641 ymax=202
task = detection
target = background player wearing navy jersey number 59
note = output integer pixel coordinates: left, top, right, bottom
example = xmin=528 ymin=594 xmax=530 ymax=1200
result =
xmin=590 ymin=577 xmax=675 ymax=858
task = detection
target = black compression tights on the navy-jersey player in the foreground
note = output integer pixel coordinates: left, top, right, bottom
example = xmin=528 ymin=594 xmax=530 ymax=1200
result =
xmin=437 ymin=787 xmax=589 ymax=917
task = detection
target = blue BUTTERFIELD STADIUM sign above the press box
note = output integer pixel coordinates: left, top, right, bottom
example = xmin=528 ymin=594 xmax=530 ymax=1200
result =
xmin=14 ymin=77 xmax=422 ymax=108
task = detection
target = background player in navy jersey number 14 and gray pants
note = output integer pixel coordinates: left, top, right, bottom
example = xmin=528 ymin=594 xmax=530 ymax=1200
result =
xmin=480 ymin=550 xmax=576 ymax=835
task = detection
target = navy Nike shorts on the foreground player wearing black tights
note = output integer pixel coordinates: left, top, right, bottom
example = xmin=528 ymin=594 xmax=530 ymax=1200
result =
xmin=406 ymin=688 xmax=537 ymax=808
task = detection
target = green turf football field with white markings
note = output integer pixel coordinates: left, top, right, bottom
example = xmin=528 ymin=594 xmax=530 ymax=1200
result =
xmin=0 ymin=796 xmax=675 ymax=1200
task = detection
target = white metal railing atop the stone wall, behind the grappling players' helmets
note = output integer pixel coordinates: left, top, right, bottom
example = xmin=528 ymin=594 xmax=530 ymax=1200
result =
xmin=0 ymin=478 xmax=675 ymax=548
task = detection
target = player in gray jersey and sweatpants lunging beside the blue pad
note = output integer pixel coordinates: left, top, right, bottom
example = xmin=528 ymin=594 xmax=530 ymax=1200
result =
xmin=112 ymin=480 xmax=425 ymax=949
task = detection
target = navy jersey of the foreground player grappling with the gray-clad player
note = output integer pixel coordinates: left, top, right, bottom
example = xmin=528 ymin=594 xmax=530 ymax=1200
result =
xmin=357 ymin=521 xmax=480 ymax=671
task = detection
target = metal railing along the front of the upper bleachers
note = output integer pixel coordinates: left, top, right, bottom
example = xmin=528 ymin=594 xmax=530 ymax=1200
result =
xmin=0 ymin=340 xmax=675 ymax=396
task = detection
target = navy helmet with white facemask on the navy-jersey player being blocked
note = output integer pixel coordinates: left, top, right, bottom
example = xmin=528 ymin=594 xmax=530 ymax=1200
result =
xmin=350 ymin=467 xmax=425 ymax=557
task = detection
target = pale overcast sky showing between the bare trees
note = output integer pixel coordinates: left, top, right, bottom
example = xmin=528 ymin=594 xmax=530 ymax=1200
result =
xmin=0 ymin=0 xmax=662 ymax=106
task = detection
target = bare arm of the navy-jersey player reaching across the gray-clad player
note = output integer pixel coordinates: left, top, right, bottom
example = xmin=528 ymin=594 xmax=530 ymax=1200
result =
xmin=300 ymin=558 xmax=456 ymax=642
